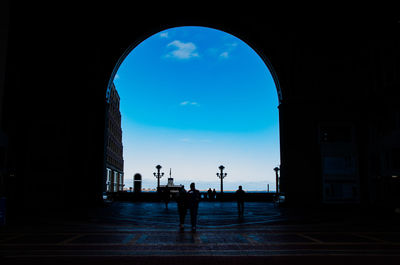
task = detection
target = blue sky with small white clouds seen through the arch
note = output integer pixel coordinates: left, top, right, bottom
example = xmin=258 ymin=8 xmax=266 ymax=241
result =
xmin=114 ymin=27 xmax=280 ymax=190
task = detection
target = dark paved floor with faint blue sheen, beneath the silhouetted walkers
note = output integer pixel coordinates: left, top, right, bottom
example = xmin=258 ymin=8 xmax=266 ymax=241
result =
xmin=0 ymin=202 xmax=400 ymax=265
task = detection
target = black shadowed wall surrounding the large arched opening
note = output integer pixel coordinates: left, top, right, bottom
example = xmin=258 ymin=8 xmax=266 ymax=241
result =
xmin=0 ymin=1 xmax=400 ymax=213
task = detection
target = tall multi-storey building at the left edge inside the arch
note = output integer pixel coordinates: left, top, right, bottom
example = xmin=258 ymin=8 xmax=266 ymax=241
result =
xmin=105 ymin=84 xmax=124 ymax=192
